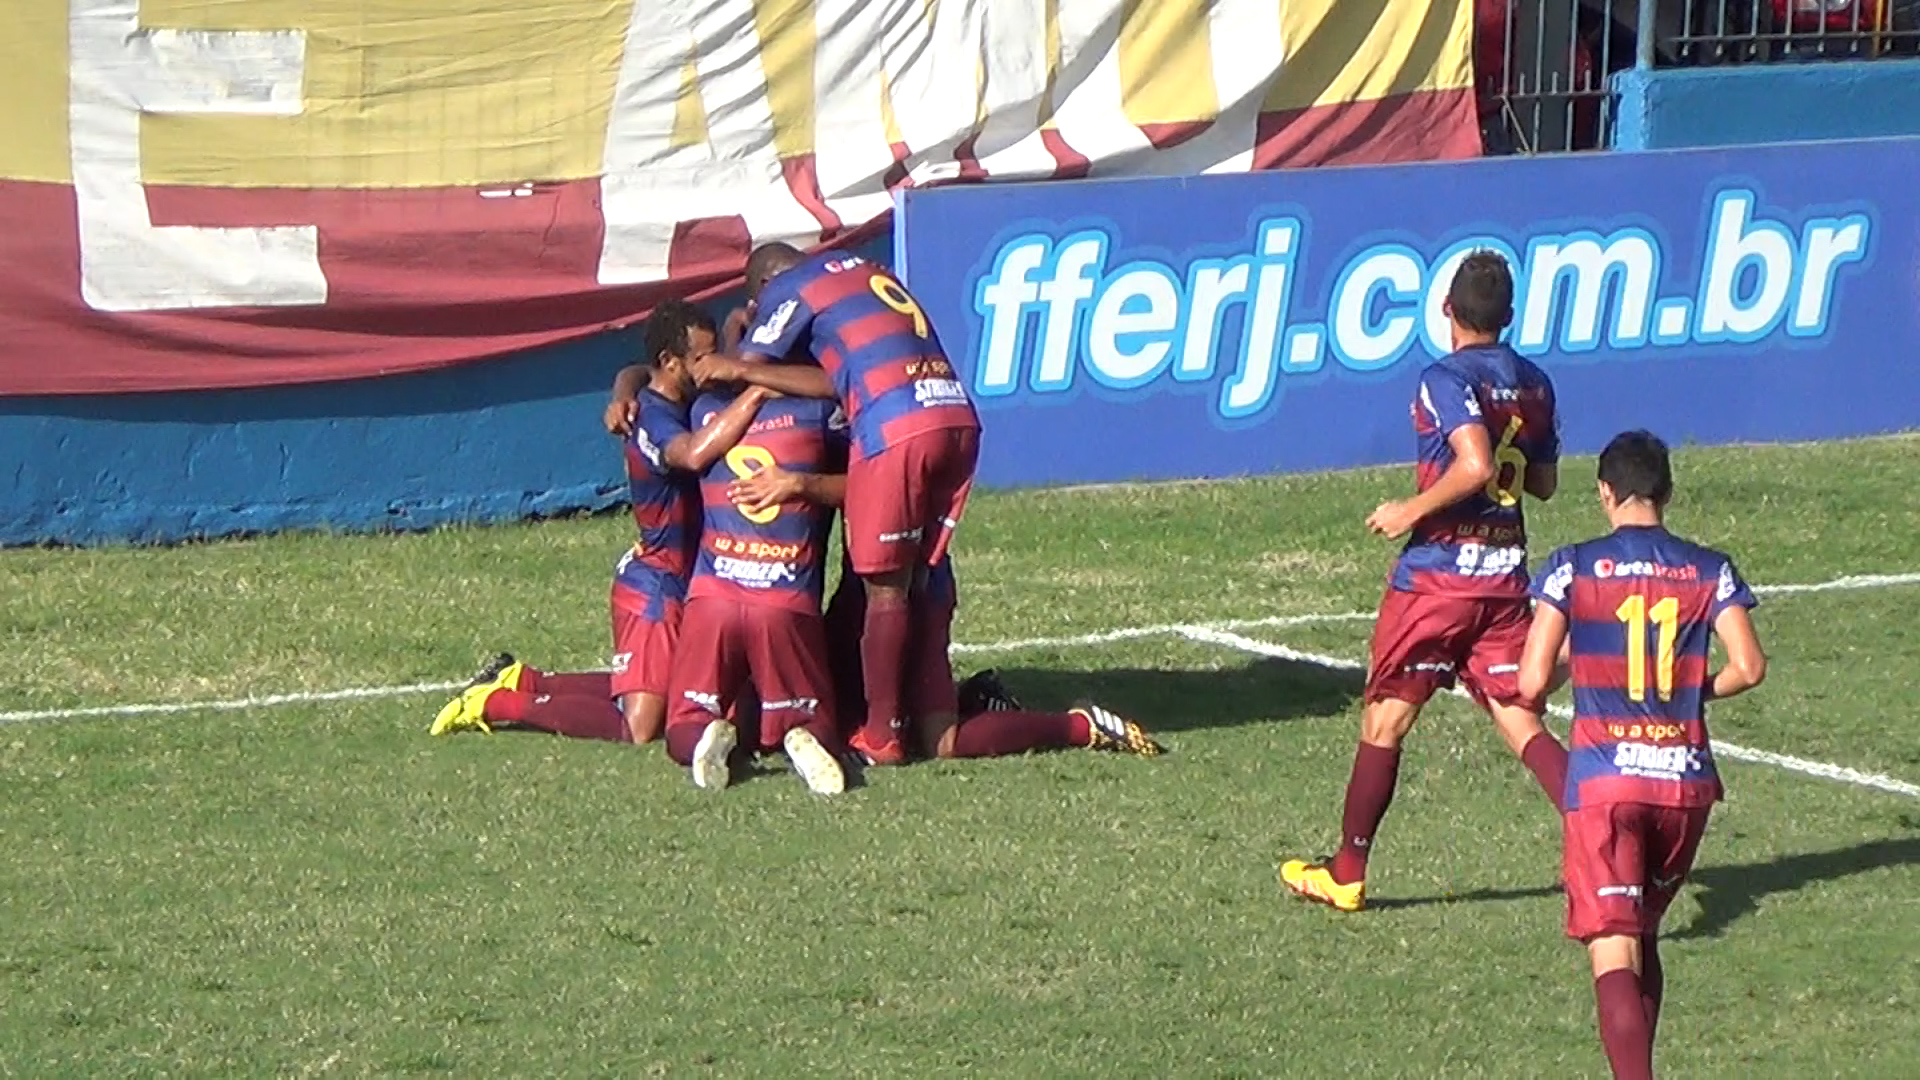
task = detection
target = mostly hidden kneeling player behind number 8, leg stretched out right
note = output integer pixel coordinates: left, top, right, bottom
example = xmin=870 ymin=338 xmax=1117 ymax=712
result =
xmin=730 ymin=467 xmax=1164 ymax=757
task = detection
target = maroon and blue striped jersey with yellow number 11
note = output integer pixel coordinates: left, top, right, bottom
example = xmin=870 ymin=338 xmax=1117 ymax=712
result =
xmin=1532 ymin=527 xmax=1757 ymax=809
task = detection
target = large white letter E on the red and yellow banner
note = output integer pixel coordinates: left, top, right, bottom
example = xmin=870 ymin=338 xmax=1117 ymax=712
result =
xmin=67 ymin=0 xmax=326 ymax=311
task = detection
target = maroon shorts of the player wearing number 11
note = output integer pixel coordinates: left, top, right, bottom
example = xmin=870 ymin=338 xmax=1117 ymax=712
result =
xmin=1561 ymin=803 xmax=1713 ymax=942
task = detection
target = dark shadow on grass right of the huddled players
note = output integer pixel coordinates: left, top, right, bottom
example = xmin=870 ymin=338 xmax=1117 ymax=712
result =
xmin=983 ymin=659 xmax=1363 ymax=732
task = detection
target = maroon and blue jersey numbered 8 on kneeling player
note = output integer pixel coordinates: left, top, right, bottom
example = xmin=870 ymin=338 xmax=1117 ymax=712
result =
xmin=687 ymin=394 xmax=847 ymax=615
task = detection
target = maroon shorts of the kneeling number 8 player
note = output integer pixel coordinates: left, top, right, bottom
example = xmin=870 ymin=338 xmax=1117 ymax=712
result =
xmin=666 ymin=596 xmax=835 ymax=749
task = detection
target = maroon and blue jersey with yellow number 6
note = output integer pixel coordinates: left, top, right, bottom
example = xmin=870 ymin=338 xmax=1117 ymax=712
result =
xmin=1392 ymin=344 xmax=1559 ymax=598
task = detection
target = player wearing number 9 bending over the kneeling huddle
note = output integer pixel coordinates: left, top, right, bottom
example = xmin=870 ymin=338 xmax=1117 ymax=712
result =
xmin=695 ymin=244 xmax=979 ymax=765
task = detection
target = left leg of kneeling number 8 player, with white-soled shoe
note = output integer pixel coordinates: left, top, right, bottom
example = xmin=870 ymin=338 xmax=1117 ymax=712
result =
xmin=666 ymin=598 xmax=745 ymax=790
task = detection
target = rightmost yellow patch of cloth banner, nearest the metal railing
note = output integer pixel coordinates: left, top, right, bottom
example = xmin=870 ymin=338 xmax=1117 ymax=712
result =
xmin=1263 ymin=0 xmax=1473 ymax=111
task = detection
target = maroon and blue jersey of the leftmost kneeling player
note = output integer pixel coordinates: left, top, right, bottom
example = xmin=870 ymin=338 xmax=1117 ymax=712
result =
xmin=614 ymin=390 xmax=701 ymax=600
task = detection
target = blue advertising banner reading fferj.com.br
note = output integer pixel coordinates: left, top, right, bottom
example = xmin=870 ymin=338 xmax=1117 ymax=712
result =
xmin=895 ymin=138 xmax=1920 ymax=486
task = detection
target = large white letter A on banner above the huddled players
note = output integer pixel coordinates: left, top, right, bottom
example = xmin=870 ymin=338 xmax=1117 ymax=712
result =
xmin=599 ymin=0 xmax=820 ymax=284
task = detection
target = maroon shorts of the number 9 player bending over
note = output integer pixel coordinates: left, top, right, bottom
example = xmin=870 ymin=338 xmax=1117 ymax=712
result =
xmin=843 ymin=427 xmax=979 ymax=575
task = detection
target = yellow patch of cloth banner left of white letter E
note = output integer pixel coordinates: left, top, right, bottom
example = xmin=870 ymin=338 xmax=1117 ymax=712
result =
xmin=0 ymin=0 xmax=73 ymax=183
